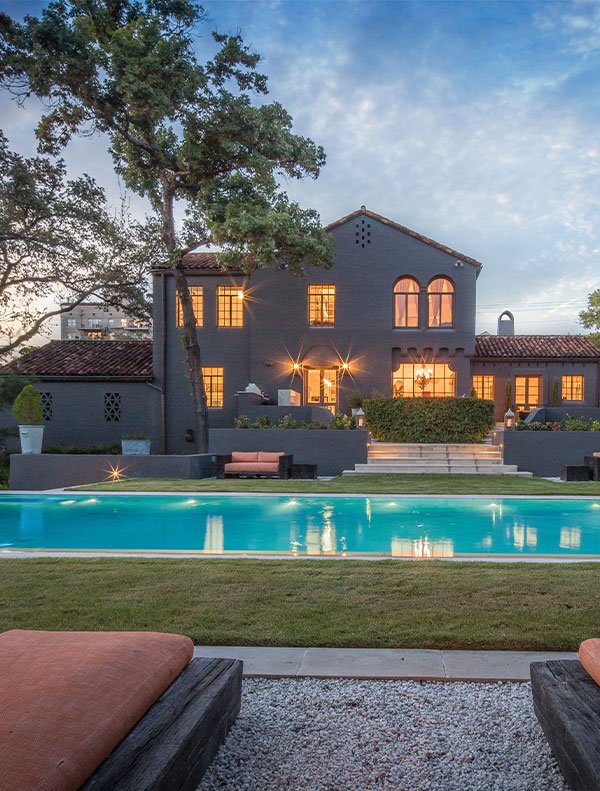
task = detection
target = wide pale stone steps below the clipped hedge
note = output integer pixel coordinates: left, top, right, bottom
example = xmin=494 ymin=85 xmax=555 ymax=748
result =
xmin=342 ymin=441 xmax=531 ymax=477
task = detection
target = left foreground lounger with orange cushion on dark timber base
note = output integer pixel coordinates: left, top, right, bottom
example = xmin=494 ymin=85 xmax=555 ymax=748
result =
xmin=0 ymin=630 xmax=242 ymax=791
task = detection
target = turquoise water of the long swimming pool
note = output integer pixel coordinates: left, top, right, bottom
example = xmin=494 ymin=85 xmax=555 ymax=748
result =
xmin=0 ymin=493 xmax=600 ymax=557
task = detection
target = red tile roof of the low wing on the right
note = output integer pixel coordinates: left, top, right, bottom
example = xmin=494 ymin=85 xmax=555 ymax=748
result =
xmin=475 ymin=335 xmax=600 ymax=360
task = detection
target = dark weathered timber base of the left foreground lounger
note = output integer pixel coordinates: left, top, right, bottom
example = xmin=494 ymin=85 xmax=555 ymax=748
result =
xmin=82 ymin=658 xmax=242 ymax=791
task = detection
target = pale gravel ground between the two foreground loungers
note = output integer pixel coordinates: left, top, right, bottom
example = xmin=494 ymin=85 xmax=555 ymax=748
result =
xmin=200 ymin=679 xmax=567 ymax=791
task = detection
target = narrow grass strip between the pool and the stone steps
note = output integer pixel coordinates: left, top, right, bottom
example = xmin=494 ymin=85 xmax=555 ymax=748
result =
xmin=77 ymin=475 xmax=600 ymax=496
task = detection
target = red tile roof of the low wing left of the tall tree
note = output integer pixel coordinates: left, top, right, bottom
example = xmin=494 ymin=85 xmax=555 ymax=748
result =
xmin=0 ymin=341 xmax=152 ymax=379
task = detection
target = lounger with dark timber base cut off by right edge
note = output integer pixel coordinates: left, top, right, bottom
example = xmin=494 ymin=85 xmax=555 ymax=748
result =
xmin=531 ymin=639 xmax=600 ymax=791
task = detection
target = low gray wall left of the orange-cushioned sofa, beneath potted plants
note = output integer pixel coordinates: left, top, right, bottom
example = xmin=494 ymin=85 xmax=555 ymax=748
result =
xmin=9 ymin=453 xmax=215 ymax=490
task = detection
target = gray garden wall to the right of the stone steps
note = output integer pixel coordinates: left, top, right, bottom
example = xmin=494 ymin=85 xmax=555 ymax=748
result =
xmin=504 ymin=431 xmax=600 ymax=477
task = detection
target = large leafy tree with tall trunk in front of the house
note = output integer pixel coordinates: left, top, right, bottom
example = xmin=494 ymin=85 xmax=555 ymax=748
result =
xmin=0 ymin=0 xmax=333 ymax=452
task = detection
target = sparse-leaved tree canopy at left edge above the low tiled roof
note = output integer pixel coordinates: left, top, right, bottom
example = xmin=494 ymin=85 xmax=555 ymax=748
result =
xmin=0 ymin=132 xmax=156 ymax=357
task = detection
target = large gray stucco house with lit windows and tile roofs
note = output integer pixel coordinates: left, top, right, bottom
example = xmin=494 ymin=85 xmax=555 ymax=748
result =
xmin=0 ymin=207 xmax=600 ymax=453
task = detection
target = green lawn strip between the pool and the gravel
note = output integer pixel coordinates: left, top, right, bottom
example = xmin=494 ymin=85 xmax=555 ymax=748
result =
xmin=0 ymin=558 xmax=600 ymax=650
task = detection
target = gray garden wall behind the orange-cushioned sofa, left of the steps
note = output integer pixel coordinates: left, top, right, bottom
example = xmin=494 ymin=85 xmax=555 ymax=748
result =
xmin=209 ymin=428 xmax=369 ymax=475
